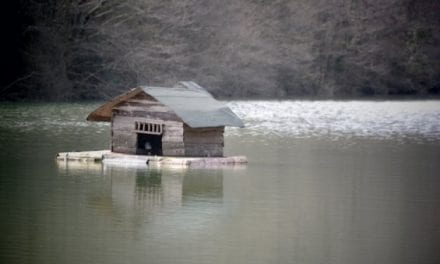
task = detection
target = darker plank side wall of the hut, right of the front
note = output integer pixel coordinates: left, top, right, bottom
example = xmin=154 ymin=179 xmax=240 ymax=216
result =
xmin=183 ymin=125 xmax=224 ymax=157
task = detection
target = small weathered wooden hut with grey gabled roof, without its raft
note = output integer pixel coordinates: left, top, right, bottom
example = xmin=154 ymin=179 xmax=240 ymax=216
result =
xmin=87 ymin=82 xmax=243 ymax=157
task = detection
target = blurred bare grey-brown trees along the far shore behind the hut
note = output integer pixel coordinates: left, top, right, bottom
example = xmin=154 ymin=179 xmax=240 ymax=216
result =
xmin=0 ymin=0 xmax=440 ymax=101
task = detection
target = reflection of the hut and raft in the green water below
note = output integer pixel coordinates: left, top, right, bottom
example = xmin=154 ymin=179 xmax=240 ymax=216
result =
xmin=58 ymin=162 xmax=223 ymax=214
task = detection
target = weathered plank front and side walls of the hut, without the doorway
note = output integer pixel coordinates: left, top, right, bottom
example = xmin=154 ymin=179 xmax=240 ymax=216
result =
xmin=112 ymin=93 xmax=224 ymax=157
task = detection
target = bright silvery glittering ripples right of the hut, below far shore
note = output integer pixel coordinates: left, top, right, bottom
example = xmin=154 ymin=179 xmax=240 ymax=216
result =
xmin=228 ymin=100 xmax=440 ymax=140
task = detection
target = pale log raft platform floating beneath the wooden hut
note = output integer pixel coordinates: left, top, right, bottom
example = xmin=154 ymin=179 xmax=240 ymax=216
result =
xmin=56 ymin=150 xmax=248 ymax=167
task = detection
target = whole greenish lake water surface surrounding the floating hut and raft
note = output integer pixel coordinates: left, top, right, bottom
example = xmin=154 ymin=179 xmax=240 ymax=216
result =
xmin=0 ymin=100 xmax=440 ymax=264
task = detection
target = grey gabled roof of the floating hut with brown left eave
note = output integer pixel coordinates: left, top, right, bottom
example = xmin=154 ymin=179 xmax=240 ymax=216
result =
xmin=87 ymin=82 xmax=244 ymax=128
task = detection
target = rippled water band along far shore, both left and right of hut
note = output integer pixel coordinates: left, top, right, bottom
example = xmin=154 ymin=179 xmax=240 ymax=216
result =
xmin=0 ymin=100 xmax=440 ymax=141
